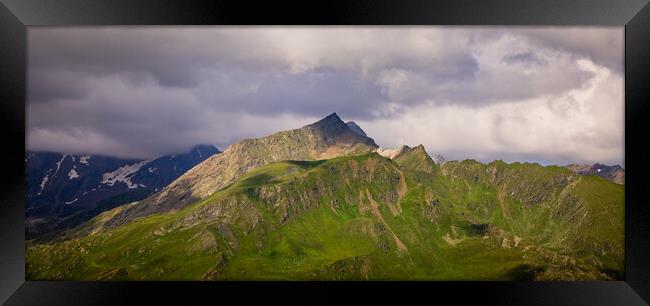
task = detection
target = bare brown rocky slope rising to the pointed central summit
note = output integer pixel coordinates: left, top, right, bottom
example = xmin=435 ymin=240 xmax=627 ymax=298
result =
xmin=98 ymin=113 xmax=377 ymax=230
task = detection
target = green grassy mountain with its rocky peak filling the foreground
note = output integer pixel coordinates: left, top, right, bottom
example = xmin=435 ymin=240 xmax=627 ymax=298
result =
xmin=27 ymin=114 xmax=624 ymax=280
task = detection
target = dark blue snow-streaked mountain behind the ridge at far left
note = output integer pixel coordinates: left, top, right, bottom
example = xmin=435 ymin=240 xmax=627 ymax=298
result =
xmin=25 ymin=145 xmax=219 ymax=238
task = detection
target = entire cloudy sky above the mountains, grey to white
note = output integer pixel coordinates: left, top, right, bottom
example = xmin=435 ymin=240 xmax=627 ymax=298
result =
xmin=26 ymin=27 xmax=624 ymax=165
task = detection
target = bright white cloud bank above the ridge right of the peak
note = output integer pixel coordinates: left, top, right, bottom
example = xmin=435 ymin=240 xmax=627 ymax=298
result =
xmin=358 ymin=60 xmax=624 ymax=164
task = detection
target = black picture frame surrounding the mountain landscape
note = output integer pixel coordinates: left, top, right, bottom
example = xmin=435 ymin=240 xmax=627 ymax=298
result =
xmin=0 ymin=0 xmax=650 ymax=305
